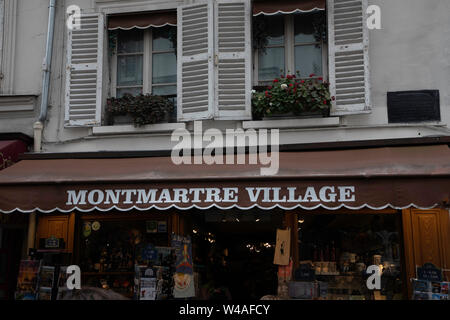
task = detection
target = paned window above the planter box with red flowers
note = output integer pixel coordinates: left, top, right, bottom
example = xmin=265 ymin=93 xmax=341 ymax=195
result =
xmin=254 ymin=12 xmax=327 ymax=85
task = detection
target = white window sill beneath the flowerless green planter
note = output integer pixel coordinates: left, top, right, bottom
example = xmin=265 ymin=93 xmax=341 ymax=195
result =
xmin=92 ymin=123 xmax=186 ymax=136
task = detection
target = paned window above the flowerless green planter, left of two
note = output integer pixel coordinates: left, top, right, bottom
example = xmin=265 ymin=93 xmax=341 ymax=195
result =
xmin=112 ymin=26 xmax=177 ymax=97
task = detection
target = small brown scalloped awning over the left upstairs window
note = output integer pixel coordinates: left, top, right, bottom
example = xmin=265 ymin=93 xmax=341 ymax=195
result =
xmin=108 ymin=10 xmax=177 ymax=30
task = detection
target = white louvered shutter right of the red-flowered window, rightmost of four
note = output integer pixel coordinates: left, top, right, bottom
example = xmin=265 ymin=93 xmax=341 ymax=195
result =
xmin=327 ymin=0 xmax=371 ymax=115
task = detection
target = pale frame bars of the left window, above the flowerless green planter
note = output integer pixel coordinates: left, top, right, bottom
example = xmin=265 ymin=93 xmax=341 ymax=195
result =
xmin=110 ymin=28 xmax=178 ymax=98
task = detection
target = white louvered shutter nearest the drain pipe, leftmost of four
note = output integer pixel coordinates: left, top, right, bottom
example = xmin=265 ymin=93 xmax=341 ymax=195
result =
xmin=65 ymin=14 xmax=104 ymax=126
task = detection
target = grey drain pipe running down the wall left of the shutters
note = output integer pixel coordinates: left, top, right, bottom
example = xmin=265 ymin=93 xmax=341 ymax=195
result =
xmin=27 ymin=0 xmax=56 ymax=254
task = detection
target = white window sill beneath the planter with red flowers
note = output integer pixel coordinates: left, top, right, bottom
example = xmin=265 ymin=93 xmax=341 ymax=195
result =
xmin=242 ymin=117 xmax=340 ymax=129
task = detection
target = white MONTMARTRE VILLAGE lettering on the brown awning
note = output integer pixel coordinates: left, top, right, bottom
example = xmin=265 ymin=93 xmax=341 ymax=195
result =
xmin=66 ymin=185 xmax=356 ymax=206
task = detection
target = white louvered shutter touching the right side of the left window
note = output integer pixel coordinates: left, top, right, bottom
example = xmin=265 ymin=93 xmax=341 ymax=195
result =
xmin=177 ymin=1 xmax=214 ymax=121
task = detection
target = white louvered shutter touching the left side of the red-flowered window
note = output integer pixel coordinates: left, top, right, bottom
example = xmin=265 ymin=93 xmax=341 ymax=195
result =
xmin=215 ymin=0 xmax=252 ymax=120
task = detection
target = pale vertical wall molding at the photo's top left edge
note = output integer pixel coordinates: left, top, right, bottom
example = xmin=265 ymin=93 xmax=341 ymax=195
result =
xmin=0 ymin=0 xmax=17 ymax=95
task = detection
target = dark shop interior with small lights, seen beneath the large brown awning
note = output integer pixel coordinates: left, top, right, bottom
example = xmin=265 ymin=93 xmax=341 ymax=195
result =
xmin=69 ymin=210 xmax=406 ymax=300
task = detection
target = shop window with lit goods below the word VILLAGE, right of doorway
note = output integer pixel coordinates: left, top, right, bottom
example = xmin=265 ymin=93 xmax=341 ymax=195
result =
xmin=294 ymin=214 xmax=406 ymax=300
